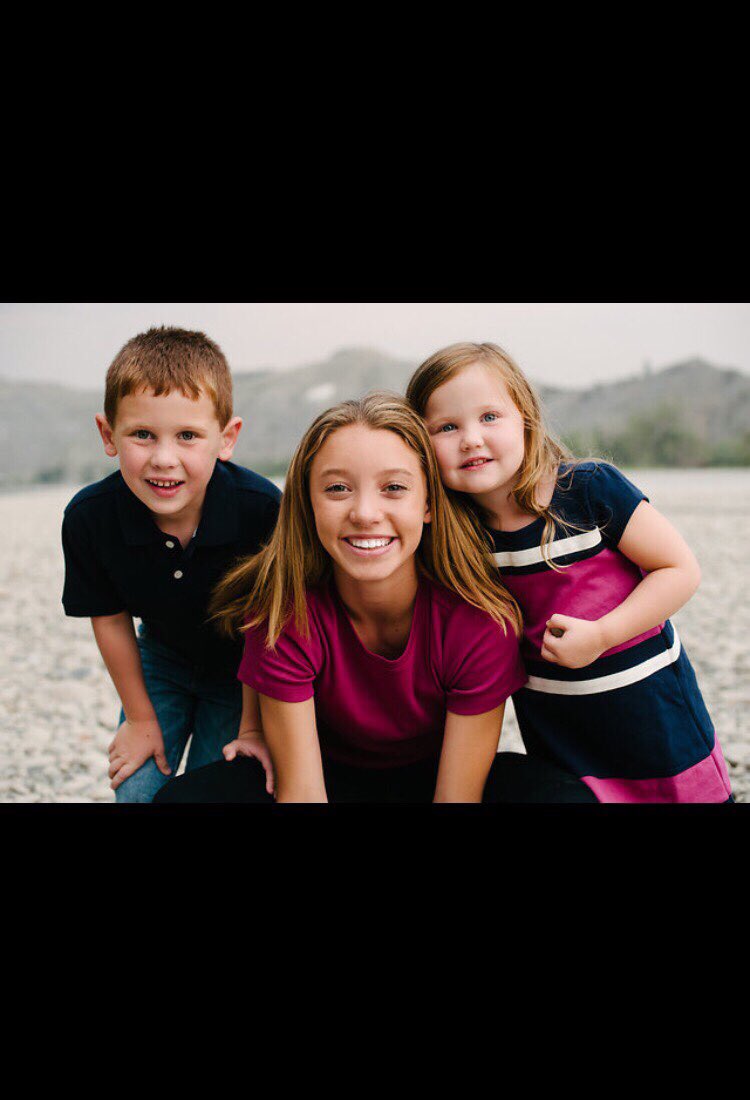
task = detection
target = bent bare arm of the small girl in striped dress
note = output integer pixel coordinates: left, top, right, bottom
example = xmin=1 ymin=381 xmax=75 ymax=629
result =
xmin=542 ymin=501 xmax=701 ymax=669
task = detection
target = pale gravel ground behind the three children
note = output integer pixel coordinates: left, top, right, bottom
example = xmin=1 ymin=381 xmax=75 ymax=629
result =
xmin=0 ymin=470 xmax=750 ymax=802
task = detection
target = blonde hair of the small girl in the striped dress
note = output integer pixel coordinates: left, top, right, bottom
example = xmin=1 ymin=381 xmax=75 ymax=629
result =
xmin=406 ymin=343 xmax=573 ymax=569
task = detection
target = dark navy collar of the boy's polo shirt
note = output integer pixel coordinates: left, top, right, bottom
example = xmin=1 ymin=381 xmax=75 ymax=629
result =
xmin=118 ymin=461 xmax=240 ymax=547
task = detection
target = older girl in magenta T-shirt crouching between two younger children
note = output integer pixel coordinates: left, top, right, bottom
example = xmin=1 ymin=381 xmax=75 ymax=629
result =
xmin=157 ymin=394 xmax=594 ymax=802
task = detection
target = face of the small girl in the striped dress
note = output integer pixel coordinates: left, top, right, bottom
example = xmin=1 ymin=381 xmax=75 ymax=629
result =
xmin=424 ymin=363 xmax=525 ymax=495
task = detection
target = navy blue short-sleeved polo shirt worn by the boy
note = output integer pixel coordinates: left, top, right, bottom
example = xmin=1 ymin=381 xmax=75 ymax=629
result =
xmin=63 ymin=462 xmax=282 ymax=674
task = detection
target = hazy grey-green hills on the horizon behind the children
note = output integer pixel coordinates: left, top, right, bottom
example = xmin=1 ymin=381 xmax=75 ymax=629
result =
xmin=0 ymin=348 xmax=750 ymax=486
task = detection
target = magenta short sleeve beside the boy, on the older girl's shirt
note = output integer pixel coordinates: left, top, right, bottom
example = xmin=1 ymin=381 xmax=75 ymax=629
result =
xmin=238 ymin=624 xmax=320 ymax=703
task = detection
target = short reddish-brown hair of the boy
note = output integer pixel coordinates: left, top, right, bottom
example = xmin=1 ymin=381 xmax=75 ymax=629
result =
xmin=104 ymin=325 xmax=232 ymax=428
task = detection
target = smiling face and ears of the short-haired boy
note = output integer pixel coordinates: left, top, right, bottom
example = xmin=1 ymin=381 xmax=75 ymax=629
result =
xmin=97 ymin=389 xmax=242 ymax=535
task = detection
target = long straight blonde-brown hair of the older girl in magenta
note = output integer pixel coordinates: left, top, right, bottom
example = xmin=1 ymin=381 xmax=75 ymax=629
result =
xmin=209 ymin=392 xmax=521 ymax=647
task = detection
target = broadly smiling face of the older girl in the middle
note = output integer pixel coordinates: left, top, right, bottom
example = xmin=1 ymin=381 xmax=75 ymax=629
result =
xmin=310 ymin=424 xmax=430 ymax=582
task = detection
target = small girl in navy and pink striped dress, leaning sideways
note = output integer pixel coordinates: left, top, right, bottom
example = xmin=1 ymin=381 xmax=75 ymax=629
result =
xmin=407 ymin=343 xmax=731 ymax=802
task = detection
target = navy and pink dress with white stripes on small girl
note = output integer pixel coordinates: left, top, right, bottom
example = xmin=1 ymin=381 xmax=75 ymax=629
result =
xmin=489 ymin=462 xmax=731 ymax=802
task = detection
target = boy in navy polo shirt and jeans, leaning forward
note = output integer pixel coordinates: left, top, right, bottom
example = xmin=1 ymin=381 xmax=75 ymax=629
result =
xmin=63 ymin=327 xmax=280 ymax=802
